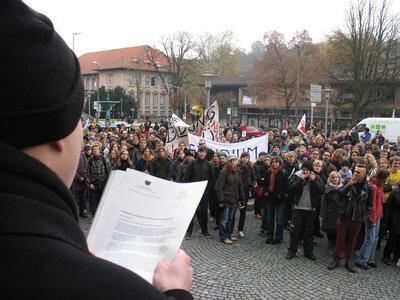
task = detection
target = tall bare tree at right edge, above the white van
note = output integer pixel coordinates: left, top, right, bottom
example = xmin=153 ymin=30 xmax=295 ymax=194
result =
xmin=325 ymin=0 xmax=400 ymax=123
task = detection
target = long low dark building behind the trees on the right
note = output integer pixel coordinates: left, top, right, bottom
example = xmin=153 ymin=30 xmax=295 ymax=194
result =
xmin=211 ymin=75 xmax=400 ymax=129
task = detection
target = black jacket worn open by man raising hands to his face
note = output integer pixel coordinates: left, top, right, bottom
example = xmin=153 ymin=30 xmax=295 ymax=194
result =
xmin=289 ymin=170 xmax=325 ymax=208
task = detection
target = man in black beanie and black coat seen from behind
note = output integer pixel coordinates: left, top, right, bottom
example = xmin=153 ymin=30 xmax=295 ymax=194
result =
xmin=0 ymin=0 xmax=193 ymax=299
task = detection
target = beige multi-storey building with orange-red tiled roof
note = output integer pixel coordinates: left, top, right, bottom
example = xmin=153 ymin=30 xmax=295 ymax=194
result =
xmin=79 ymin=45 xmax=171 ymax=118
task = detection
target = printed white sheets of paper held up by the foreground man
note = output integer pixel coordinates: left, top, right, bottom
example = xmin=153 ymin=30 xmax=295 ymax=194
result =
xmin=87 ymin=170 xmax=207 ymax=283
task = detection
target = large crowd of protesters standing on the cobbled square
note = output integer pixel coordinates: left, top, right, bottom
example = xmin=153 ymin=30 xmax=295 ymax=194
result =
xmin=76 ymin=118 xmax=400 ymax=272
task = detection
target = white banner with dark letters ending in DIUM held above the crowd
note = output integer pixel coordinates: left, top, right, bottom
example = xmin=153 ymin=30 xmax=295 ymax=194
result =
xmin=189 ymin=133 xmax=268 ymax=162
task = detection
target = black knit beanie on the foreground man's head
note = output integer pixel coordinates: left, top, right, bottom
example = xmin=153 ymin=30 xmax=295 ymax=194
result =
xmin=0 ymin=0 xmax=84 ymax=148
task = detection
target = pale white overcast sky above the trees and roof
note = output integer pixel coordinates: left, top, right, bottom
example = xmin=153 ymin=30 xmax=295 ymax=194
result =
xmin=25 ymin=0 xmax=400 ymax=55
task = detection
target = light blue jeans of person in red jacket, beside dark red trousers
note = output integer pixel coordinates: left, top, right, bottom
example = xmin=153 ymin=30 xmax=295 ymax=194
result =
xmin=357 ymin=218 xmax=381 ymax=265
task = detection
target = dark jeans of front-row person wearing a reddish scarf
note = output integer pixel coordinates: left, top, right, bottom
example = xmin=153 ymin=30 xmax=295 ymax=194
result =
xmin=266 ymin=203 xmax=285 ymax=241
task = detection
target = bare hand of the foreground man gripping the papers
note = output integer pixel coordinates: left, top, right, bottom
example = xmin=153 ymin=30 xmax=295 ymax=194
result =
xmin=153 ymin=250 xmax=193 ymax=292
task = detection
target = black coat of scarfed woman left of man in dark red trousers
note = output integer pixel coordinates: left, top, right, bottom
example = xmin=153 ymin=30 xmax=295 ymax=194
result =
xmin=320 ymin=185 xmax=341 ymax=234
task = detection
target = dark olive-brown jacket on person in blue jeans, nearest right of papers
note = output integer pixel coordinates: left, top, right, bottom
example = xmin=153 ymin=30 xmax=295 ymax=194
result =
xmin=215 ymin=167 xmax=245 ymax=207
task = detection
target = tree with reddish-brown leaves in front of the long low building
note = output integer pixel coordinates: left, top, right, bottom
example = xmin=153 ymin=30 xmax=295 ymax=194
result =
xmin=252 ymin=31 xmax=319 ymax=122
